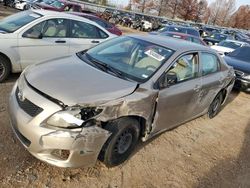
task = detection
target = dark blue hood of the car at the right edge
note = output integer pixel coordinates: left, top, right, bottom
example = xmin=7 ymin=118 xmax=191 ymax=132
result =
xmin=224 ymin=56 xmax=250 ymax=74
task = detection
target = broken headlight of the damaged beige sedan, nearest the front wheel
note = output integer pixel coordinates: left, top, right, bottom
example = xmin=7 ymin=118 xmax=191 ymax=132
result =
xmin=46 ymin=107 xmax=102 ymax=128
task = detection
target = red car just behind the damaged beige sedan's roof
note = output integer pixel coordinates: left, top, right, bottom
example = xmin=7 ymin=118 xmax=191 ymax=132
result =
xmin=160 ymin=32 xmax=207 ymax=46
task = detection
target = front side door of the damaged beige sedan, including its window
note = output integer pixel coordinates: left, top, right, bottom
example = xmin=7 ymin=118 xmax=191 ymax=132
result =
xmin=150 ymin=53 xmax=202 ymax=134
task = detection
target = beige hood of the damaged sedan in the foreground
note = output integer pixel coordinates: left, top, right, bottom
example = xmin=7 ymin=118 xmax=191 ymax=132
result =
xmin=25 ymin=55 xmax=137 ymax=106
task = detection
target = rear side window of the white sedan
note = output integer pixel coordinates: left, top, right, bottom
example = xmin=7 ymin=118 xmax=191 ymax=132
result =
xmin=71 ymin=21 xmax=108 ymax=39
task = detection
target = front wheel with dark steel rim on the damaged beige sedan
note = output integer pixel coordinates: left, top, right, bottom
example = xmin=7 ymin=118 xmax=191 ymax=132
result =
xmin=99 ymin=118 xmax=140 ymax=167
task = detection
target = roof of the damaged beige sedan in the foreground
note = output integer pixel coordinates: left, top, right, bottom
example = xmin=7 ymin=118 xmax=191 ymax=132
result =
xmin=127 ymin=35 xmax=209 ymax=52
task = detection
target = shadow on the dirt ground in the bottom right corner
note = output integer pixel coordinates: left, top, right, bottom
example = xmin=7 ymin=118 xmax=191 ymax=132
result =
xmin=195 ymin=120 xmax=250 ymax=188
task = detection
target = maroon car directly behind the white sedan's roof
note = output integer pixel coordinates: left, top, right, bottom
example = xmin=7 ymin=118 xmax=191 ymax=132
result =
xmin=70 ymin=12 xmax=122 ymax=36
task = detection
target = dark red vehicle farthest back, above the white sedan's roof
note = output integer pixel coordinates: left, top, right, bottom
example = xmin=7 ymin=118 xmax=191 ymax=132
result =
xmin=35 ymin=0 xmax=82 ymax=12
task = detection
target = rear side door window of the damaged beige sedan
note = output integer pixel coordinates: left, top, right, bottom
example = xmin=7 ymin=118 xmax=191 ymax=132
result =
xmin=200 ymin=52 xmax=220 ymax=76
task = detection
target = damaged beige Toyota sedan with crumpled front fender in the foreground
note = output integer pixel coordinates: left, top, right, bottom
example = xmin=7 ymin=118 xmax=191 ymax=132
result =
xmin=9 ymin=35 xmax=234 ymax=167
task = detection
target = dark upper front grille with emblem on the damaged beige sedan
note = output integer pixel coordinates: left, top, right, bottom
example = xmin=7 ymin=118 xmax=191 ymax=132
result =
xmin=16 ymin=87 xmax=43 ymax=117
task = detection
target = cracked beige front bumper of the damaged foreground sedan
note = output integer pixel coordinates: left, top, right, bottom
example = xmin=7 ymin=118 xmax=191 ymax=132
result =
xmin=9 ymin=84 xmax=110 ymax=167
